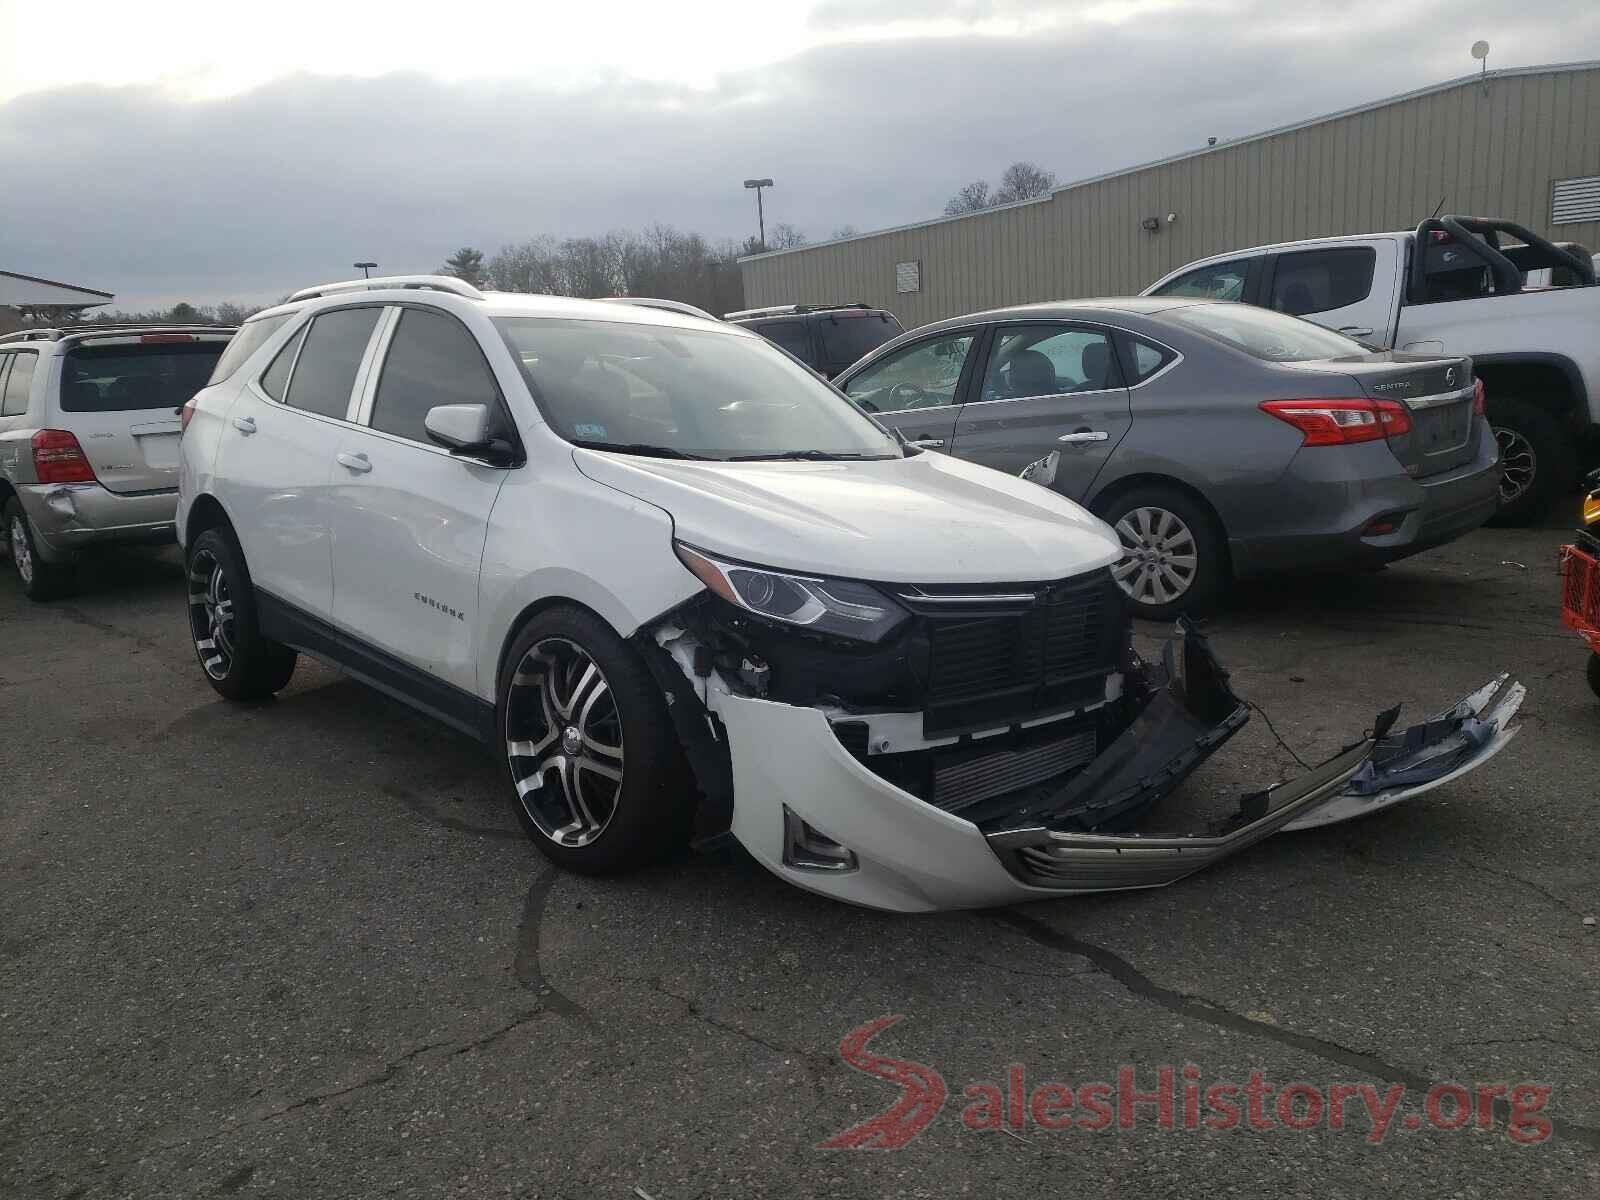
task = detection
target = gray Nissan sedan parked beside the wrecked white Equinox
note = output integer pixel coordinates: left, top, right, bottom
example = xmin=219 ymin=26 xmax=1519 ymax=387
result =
xmin=835 ymin=298 xmax=1499 ymax=619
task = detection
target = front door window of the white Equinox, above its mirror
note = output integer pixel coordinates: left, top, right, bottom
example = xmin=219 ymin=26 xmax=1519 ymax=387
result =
xmin=371 ymin=309 xmax=499 ymax=442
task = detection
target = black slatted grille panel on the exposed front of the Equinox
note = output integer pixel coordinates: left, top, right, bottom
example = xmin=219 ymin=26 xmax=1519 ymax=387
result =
xmin=910 ymin=570 xmax=1122 ymax=736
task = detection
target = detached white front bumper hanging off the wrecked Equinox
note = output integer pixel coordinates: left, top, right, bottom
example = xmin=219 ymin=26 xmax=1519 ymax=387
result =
xmin=656 ymin=624 xmax=1525 ymax=912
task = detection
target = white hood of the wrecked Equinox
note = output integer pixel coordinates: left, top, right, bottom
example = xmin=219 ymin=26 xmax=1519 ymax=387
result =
xmin=573 ymin=448 xmax=1122 ymax=584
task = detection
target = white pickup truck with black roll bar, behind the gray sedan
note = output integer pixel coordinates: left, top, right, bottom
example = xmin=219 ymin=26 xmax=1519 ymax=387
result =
xmin=1144 ymin=216 xmax=1600 ymax=525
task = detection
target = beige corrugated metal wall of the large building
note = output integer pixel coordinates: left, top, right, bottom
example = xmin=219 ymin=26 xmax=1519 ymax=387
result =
xmin=742 ymin=67 xmax=1600 ymax=328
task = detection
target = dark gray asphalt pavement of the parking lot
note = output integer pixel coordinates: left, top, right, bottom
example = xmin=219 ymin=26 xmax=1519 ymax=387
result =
xmin=0 ymin=528 xmax=1600 ymax=1200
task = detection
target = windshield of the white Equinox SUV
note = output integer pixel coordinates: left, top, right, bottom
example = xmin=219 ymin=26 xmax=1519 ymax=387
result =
xmin=494 ymin=317 xmax=901 ymax=459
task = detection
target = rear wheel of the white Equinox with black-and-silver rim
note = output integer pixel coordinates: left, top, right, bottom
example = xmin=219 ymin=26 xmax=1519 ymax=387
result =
xmin=186 ymin=530 xmax=299 ymax=701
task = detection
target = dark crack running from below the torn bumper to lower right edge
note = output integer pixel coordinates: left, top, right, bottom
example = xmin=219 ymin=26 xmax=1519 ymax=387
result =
xmin=989 ymin=909 xmax=1600 ymax=1149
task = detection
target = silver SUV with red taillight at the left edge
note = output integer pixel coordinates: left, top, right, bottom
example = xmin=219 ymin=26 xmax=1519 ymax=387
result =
xmin=0 ymin=325 xmax=233 ymax=600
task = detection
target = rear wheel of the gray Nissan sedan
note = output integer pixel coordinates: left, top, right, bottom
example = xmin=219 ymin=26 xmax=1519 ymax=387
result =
xmin=1102 ymin=483 xmax=1229 ymax=621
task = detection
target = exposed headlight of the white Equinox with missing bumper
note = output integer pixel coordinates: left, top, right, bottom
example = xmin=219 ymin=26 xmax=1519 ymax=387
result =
xmin=674 ymin=542 xmax=909 ymax=642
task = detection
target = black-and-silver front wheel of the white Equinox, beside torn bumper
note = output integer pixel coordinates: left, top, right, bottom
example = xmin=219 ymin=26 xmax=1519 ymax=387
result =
xmin=498 ymin=608 xmax=694 ymax=874
